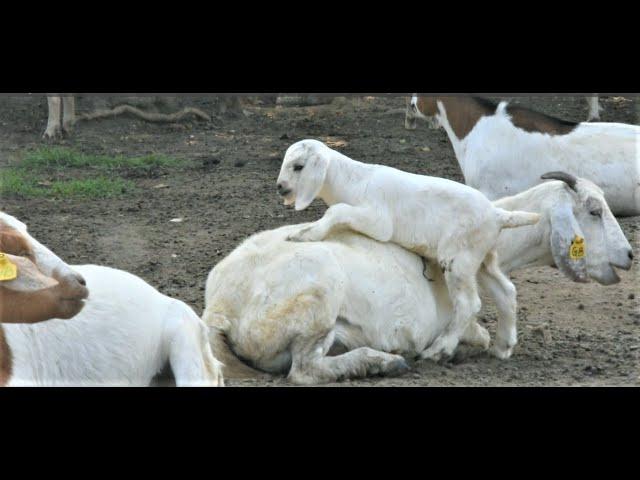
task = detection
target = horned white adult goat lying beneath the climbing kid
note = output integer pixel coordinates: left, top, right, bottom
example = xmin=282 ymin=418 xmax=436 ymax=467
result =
xmin=203 ymin=175 xmax=632 ymax=384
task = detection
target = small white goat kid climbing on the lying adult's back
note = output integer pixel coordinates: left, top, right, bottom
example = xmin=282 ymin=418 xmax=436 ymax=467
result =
xmin=278 ymin=140 xmax=539 ymax=360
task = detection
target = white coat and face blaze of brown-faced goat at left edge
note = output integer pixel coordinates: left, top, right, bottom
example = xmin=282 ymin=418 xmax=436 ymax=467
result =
xmin=0 ymin=212 xmax=223 ymax=386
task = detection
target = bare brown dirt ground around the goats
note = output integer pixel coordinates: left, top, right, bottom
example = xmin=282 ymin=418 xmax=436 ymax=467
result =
xmin=0 ymin=96 xmax=640 ymax=386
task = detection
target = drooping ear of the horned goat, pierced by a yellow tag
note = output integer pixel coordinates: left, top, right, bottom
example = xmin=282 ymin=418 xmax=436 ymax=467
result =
xmin=551 ymin=205 xmax=589 ymax=283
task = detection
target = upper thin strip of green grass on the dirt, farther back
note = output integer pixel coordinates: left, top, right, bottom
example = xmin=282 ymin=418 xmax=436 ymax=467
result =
xmin=18 ymin=147 xmax=182 ymax=170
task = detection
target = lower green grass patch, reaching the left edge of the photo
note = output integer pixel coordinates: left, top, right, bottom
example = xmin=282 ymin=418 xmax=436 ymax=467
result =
xmin=0 ymin=169 xmax=136 ymax=198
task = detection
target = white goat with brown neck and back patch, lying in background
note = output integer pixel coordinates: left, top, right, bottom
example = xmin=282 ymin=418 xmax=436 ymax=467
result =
xmin=405 ymin=95 xmax=640 ymax=215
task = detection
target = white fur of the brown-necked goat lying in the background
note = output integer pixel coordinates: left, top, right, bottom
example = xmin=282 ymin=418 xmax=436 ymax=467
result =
xmin=412 ymin=96 xmax=640 ymax=215
